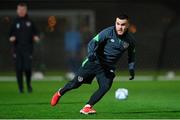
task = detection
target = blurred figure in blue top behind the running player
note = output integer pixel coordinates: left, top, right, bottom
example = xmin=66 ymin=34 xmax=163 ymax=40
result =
xmin=64 ymin=20 xmax=81 ymax=80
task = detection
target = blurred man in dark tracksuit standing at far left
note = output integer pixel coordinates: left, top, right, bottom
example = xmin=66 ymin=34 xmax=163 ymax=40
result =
xmin=9 ymin=3 xmax=40 ymax=93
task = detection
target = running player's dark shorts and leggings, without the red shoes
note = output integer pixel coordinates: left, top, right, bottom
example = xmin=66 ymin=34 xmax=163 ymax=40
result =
xmin=60 ymin=61 xmax=115 ymax=105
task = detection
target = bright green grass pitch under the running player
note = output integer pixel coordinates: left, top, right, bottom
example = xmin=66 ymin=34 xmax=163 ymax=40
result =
xmin=0 ymin=81 xmax=180 ymax=119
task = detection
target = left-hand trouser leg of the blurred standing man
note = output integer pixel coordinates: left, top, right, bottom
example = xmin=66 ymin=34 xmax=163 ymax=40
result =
xmin=14 ymin=54 xmax=24 ymax=93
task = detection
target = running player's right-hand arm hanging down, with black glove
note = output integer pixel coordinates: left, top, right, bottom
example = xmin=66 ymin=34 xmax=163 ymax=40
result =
xmin=128 ymin=41 xmax=136 ymax=80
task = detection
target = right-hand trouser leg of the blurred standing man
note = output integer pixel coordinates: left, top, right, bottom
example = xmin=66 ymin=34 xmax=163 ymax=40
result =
xmin=23 ymin=54 xmax=32 ymax=93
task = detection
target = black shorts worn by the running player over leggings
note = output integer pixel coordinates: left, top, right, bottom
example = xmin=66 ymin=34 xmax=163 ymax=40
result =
xmin=74 ymin=60 xmax=115 ymax=84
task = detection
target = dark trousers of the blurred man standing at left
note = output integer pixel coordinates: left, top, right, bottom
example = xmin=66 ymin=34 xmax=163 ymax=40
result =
xmin=14 ymin=52 xmax=32 ymax=92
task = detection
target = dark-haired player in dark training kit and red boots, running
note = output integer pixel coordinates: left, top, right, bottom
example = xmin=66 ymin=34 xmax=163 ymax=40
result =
xmin=51 ymin=14 xmax=135 ymax=114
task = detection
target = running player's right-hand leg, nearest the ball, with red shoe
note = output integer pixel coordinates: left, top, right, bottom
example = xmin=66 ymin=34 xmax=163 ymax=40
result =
xmin=80 ymin=72 xmax=115 ymax=114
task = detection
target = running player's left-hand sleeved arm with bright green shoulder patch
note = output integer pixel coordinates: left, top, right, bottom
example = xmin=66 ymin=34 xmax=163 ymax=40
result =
xmin=88 ymin=28 xmax=110 ymax=61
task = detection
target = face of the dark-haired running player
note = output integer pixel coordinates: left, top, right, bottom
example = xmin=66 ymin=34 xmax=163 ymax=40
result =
xmin=115 ymin=18 xmax=129 ymax=35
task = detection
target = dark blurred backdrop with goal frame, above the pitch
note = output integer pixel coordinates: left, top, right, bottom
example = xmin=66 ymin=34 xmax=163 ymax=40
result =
xmin=0 ymin=0 xmax=180 ymax=71
